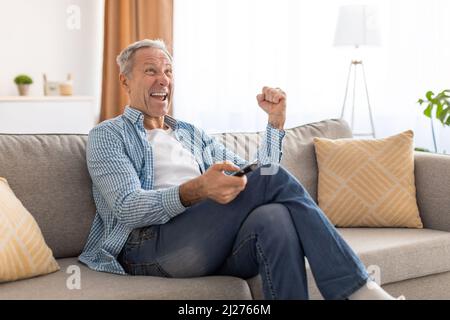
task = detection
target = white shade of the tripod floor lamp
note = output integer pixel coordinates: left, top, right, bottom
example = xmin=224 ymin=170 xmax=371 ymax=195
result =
xmin=334 ymin=5 xmax=381 ymax=47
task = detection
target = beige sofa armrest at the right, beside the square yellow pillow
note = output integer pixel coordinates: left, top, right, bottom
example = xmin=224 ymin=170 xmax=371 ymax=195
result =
xmin=414 ymin=152 xmax=450 ymax=231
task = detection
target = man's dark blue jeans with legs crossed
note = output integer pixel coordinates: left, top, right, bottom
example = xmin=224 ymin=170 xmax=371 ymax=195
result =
xmin=118 ymin=165 xmax=369 ymax=299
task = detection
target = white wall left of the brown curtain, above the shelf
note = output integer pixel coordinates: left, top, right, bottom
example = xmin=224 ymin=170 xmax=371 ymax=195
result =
xmin=0 ymin=0 xmax=104 ymax=119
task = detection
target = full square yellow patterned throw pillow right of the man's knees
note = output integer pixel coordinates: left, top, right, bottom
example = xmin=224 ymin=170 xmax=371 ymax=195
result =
xmin=314 ymin=130 xmax=423 ymax=228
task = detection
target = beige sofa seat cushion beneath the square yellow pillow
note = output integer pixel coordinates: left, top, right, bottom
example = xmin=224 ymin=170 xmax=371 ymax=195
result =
xmin=248 ymin=228 xmax=450 ymax=298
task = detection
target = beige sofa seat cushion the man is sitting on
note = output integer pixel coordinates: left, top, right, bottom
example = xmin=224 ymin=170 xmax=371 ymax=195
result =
xmin=0 ymin=258 xmax=252 ymax=300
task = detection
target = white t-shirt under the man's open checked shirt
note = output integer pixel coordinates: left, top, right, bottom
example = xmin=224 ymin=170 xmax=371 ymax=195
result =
xmin=147 ymin=128 xmax=201 ymax=189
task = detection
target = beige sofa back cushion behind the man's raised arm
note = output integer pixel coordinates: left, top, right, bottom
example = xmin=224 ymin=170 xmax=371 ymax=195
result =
xmin=213 ymin=119 xmax=352 ymax=201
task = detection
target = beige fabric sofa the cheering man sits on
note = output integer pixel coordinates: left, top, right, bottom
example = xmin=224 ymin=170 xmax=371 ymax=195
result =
xmin=0 ymin=120 xmax=450 ymax=299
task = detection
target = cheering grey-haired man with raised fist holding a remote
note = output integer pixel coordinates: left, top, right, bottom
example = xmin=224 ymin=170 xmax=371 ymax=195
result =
xmin=79 ymin=40 xmax=400 ymax=299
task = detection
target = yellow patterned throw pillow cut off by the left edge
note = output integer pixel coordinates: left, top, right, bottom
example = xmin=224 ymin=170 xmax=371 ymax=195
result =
xmin=0 ymin=178 xmax=59 ymax=282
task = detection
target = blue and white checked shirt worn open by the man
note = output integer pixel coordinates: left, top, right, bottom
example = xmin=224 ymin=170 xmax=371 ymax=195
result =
xmin=79 ymin=106 xmax=285 ymax=274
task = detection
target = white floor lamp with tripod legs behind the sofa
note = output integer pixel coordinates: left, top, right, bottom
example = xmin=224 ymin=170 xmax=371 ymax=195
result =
xmin=334 ymin=5 xmax=380 ymax=138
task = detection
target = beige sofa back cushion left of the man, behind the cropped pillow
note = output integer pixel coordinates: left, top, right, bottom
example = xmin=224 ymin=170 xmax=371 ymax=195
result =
xmin=0 ymin=134 xmax=95 ymax=258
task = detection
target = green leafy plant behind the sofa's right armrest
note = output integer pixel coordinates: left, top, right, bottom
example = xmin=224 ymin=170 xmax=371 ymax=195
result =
xmin=417 ymin=89 xmax=450 ymax=152
